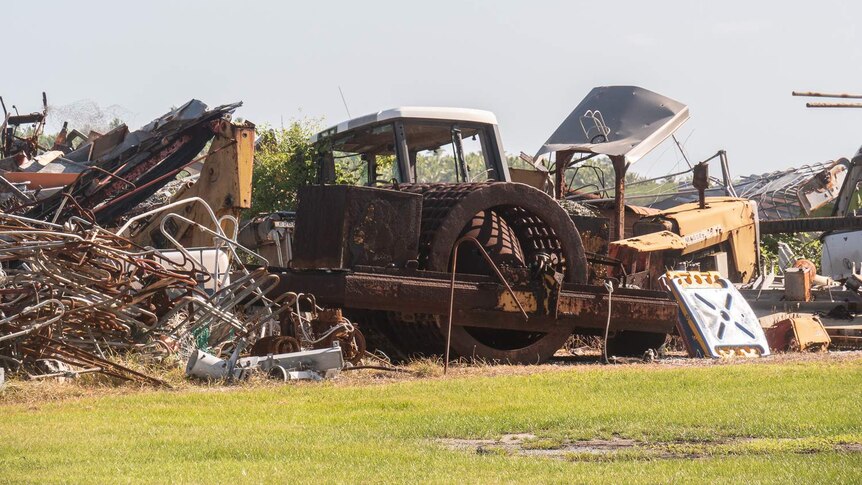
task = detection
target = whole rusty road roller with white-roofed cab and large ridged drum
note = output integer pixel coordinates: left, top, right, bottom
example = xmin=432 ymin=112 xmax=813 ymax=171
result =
xmin=250 ymin=108 xmax=678 ymax=364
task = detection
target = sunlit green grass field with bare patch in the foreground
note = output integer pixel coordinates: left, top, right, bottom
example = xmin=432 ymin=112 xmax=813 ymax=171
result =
xmin=0 ymin=356 xmax=862 ymax=483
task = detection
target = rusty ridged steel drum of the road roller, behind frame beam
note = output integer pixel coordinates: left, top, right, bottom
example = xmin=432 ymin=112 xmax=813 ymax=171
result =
xmin=374 ymin=182 xmax=587 ymax=363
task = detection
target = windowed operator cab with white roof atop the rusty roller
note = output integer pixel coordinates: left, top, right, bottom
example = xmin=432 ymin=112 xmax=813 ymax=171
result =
xmin=311 ymin=107 xmax=509 ymax=186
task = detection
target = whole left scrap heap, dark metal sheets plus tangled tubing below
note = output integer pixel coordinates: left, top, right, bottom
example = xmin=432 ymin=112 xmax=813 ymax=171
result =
xmin=0 ymin=100 xmax=365 ymax=385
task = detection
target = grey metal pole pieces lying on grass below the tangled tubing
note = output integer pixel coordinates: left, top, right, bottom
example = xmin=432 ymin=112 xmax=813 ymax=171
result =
xmin=186 ymin=342 xmax=344 ymax=380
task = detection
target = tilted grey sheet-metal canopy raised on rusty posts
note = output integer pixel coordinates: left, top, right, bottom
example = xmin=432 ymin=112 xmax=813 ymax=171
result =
xmin=536 ymin=86 xmax=689 ymax=163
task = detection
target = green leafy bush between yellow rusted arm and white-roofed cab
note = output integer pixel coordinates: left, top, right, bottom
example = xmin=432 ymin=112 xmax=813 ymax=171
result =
xmin=251 ymin=120 xmax=319 ymax=214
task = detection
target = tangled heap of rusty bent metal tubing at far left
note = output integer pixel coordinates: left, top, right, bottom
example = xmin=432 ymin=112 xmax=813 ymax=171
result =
xmin=0 ymin=202 xmax=364 ymax=385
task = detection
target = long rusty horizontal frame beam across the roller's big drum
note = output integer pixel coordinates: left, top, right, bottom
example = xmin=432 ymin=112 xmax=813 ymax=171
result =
xmin=276 ymin=267 xmax=678 ymax=363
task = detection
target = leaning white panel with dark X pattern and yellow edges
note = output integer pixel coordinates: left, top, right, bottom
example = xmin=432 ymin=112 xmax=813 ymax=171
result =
xmin=667 ymin=271 xmax=769 ymax=358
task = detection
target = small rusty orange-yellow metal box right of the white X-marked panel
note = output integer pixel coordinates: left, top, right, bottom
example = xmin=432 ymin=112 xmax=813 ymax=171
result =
xmin=760 ymin=313 xmax=831 ymax=352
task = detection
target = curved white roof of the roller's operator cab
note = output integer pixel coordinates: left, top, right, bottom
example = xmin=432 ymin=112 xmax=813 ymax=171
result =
xmin=311 ymin=106 xmax=497 ymax=143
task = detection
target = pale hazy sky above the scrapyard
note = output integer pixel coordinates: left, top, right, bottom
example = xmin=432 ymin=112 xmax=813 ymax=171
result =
xmin=5 ymin=0 xmax=862 ymax=176
